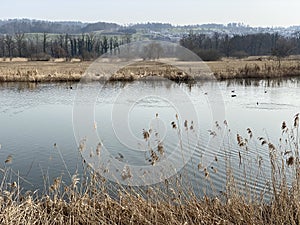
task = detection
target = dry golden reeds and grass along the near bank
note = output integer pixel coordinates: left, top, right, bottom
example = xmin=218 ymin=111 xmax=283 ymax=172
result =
xmin=0 ymin=114 xmax=300 ymax=224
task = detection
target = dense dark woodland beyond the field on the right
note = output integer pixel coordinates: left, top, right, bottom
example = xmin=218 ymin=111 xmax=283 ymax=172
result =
xmin=180 ymin=32 xmax=300 ymax=61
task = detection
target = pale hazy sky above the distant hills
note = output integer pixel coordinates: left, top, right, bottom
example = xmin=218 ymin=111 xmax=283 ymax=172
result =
xmin=0 ymin=0 xmax=300 ymax=27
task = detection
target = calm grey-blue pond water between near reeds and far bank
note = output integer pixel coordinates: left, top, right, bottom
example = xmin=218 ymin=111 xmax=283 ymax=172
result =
xmin=0 ymin=78 xmax=300 ymax=197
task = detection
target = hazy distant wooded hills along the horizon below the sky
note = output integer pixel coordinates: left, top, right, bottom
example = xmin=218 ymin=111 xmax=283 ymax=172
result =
xmin=0 ymin=19 xmax=300 ymax=36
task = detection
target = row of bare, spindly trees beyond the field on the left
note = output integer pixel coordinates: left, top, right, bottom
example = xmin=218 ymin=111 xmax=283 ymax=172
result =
xmin=0 ymin=33 xmax=131 ymax=61
